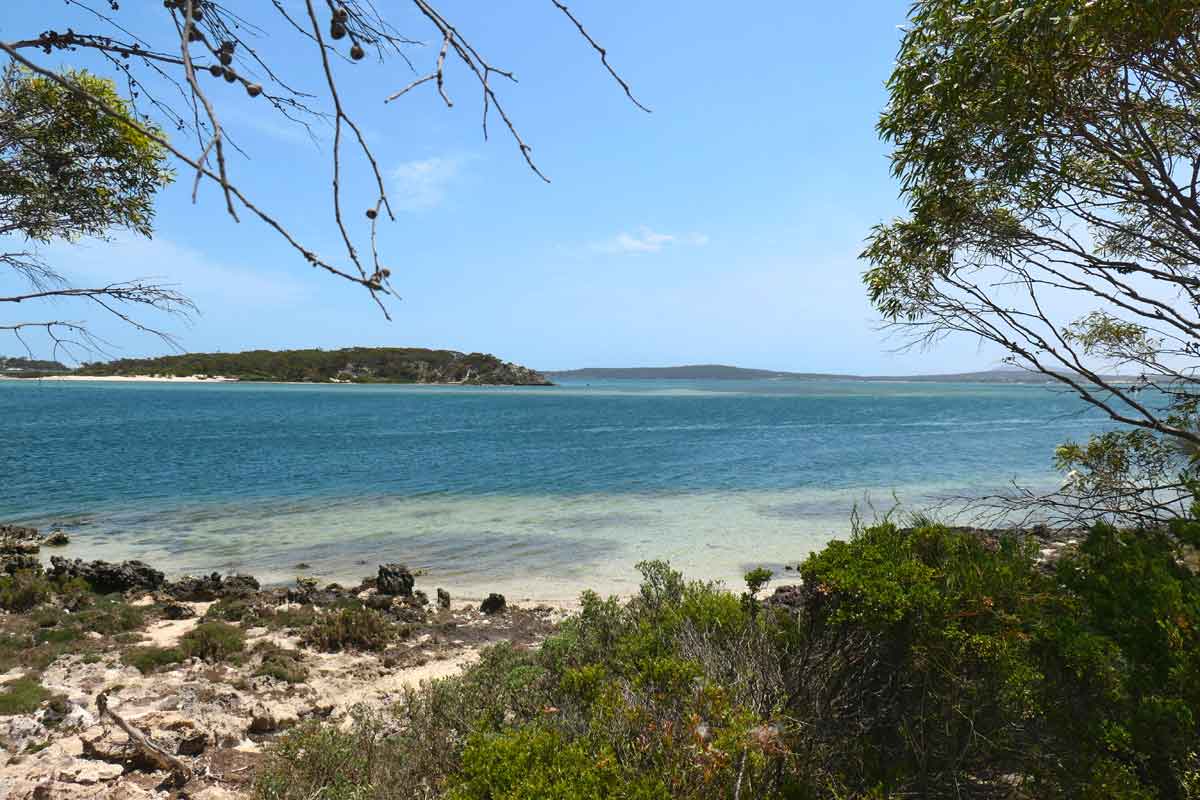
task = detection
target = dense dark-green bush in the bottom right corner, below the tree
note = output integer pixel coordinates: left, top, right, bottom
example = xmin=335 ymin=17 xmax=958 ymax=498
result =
xmin=791 ymin=524 xmax=1200 ymax=798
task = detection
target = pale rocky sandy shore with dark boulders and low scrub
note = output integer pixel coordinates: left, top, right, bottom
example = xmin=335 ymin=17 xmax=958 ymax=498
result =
xmin=0 ymin=525 xmax=564 ymax=800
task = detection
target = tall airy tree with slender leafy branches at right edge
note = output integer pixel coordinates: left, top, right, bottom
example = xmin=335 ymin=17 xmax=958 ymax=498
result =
xmin=864 ymin=0 xmax=1200 ymax=523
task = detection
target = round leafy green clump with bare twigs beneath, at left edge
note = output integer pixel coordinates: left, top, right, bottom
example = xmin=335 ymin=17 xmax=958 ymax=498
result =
xmin=0 ymin=64 xmax=192 ymax=351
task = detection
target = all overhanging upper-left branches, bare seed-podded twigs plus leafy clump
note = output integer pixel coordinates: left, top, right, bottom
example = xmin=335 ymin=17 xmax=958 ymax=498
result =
xmin=0 ymin=0 xmax=648 ymax=357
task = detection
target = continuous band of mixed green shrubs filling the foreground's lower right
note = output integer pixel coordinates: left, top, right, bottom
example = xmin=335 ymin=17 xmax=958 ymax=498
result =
xmin=257 ymin=513 xmax=1200 ymax=800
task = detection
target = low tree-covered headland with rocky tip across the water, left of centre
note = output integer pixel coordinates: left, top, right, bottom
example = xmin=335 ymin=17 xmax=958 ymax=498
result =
xmin=76 ymin=348 xmax=550 ymax=386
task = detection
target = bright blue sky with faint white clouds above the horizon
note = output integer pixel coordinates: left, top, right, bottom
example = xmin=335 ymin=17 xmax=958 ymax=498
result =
xmin=0 ymin=0 xmax=1012 ymax=374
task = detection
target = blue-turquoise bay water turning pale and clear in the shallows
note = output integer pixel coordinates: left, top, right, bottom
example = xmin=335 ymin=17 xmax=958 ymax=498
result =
xmin=0 ymin=380 xmax=1103 ymax=600
